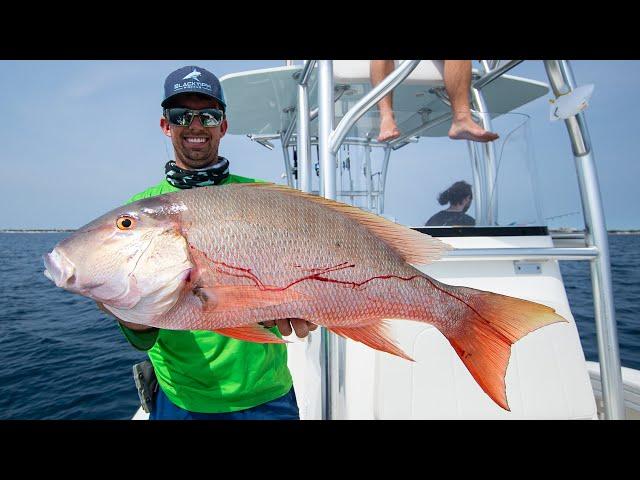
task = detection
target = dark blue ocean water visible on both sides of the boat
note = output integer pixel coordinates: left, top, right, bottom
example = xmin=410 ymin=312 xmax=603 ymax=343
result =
xmin=0 ymin=233 xmax=640 ymax=419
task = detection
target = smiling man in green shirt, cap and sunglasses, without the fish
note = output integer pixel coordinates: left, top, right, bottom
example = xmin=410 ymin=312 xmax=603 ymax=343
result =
xmin=102 ymin=66 xmax=317 ymax=420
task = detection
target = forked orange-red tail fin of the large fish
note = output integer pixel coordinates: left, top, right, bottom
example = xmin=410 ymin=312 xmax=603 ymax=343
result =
xmin=422 ymin=279 xmax=566 ymax=411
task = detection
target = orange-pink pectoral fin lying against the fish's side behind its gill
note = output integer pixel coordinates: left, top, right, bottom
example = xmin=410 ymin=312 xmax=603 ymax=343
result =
xmin=193 ymin=285 xmax=305 ymax=312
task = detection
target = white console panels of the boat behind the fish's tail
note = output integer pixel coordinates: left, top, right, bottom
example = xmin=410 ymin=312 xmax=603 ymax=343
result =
xmin=289 ymin=236 xmax=597 ymax=419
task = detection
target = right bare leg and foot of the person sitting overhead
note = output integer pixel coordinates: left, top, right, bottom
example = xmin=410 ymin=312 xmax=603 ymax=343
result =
xmin=444 ymin=60 xmax=498 ymax=142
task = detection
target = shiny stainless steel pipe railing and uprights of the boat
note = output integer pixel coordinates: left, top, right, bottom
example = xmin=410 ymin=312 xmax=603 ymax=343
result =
xmin=297 ymin=60 xmax=624 ymax=419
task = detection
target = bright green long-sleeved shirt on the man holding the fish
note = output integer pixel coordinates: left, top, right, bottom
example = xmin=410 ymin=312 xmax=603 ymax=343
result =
xmin=120 ymin=175 xmax=293 ymax=413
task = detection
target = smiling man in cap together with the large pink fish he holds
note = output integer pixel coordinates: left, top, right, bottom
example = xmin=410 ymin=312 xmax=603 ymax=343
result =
xmin=44 ymin=67 xmax=566 ymax=419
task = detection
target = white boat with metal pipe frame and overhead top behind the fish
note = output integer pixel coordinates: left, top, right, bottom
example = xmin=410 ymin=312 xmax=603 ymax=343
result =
xmin=134 ymin=60 xmax=640 ymax=419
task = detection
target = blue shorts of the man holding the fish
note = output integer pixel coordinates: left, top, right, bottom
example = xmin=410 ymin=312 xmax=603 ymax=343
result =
xmin=149 ymin=387 xmax=300 ymax=420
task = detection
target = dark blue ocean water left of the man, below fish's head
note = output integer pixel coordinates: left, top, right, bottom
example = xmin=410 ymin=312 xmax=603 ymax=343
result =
xmin=0 ymin=233 xmax=146 ymax=419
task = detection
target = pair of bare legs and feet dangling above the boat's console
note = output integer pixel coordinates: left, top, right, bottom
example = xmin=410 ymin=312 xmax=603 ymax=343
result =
xmin=370 ymin=60 xmax=498 ymax=142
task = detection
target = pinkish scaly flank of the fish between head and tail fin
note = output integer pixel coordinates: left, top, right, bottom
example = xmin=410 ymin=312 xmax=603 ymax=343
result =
xmin=152 ymin=185 xmax=464 ymax=336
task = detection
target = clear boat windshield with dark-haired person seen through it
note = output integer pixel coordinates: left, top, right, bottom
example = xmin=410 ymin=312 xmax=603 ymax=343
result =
xmin=336 ymin=109 xmax=545 ymax=227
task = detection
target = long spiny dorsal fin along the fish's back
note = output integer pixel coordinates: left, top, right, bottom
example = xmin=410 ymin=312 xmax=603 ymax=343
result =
xmin=233 ymin=183 xmax=452 ymax=265
